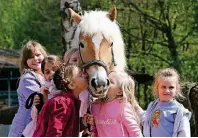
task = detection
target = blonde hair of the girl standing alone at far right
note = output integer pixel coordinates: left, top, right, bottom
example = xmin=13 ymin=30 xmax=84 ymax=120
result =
xmin=153 ymin=68 xmax=185 ymax=99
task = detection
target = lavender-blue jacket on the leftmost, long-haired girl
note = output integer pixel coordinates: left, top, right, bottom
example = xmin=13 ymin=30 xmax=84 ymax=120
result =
xmin=8 ymin=69 xmax=42 ymax=137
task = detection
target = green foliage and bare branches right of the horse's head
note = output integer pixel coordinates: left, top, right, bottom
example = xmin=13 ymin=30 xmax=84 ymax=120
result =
xmin=81 ymin=0 xmax=198 ymax=81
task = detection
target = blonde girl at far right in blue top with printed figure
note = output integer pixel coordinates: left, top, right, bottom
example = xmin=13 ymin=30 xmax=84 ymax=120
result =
xmin=143 ymin=68 xmax=191 ymax=137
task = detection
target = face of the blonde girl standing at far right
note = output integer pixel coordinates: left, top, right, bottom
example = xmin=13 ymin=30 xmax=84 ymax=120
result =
xmin=158 ymin=77 xmax=177 ymax=102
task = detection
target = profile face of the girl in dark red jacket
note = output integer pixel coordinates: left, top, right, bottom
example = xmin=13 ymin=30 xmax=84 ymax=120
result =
xmin=72 ymin=68 xmax=88 ymax=93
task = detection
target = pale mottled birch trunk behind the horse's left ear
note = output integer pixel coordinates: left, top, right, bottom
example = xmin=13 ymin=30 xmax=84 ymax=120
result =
xmin=60 ymin=0 xmax=81 ymax=53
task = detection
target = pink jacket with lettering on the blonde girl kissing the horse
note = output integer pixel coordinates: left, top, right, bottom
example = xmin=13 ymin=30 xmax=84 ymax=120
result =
xmin=91 ymin=99 xmax=142 ymax=137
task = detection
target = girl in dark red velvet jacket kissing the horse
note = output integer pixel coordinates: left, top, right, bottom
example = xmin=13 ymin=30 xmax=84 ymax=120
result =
xmin=33 ymin=64 xmax=88 ymax=137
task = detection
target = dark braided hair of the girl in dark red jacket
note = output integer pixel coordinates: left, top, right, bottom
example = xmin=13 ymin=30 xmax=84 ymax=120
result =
xmin=53 ymin=63 xmax=78 ymax=92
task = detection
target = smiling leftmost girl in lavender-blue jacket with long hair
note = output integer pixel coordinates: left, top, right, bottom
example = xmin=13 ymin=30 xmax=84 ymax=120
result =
xmin=8 ymin=41 xmax=47 ymax=137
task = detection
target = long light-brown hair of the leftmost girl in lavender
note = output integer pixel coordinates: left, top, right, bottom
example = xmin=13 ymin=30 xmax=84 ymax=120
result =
xmin=20 ymin=40 xmax=47 ymax=74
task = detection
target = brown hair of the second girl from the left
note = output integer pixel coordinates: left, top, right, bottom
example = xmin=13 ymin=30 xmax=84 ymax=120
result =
xmin=41 ymin=55 xmax=61 ymax=74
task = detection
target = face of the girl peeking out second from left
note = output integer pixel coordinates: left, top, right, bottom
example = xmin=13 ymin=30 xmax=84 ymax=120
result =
xmin=44 ymin=62 xmax=57 ymax=81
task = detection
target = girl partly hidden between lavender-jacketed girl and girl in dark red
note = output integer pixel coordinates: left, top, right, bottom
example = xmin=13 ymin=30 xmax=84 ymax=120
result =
xmin=23 ymin=55 xmax=60 ymax=137
